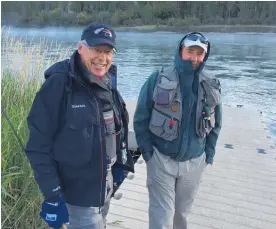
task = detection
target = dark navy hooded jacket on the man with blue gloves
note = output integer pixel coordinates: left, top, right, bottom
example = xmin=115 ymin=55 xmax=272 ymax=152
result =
xmin=26 ymin=52 xmax=131 ymax=207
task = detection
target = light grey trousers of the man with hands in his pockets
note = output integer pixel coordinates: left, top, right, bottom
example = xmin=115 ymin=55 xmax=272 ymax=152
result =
xmin=147 ymin=148 xmax=206 ymax=229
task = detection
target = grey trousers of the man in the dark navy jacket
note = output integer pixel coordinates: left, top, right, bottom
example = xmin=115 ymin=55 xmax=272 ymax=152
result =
xmin=67 ymin=170 xmax=113 ymax=229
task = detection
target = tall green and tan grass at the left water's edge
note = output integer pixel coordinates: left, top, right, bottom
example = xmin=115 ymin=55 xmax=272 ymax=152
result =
xmin=1 ymin=31 xmax=69 ymax=229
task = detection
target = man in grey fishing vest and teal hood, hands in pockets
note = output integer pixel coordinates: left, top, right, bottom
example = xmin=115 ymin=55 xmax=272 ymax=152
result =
xmin=134 ymin=32 xmax=221 ymax=229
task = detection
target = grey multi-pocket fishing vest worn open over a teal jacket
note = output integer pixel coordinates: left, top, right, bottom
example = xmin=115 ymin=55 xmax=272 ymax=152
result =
xmin=149 ymin=67 xmax=221 ymax=141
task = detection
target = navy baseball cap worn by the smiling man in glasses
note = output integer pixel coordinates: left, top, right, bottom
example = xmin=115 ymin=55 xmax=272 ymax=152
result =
xmin=81 ymin=24 xmax=116 ymax=49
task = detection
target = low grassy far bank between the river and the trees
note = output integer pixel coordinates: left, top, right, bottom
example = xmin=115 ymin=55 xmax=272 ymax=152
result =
xmin=115 ymin=25 xmax=276 ymax=33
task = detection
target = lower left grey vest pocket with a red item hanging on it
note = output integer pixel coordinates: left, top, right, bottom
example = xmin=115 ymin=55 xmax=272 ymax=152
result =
xmin=149 ymin=109 xmax=179 ymax=141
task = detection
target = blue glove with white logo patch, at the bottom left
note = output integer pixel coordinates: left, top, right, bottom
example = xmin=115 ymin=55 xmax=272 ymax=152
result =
xmin=40 ymin=197 xmax=69 ymax=229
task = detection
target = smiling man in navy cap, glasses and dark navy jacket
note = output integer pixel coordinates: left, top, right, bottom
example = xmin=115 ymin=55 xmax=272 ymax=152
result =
xmin=26 ymin=24 xmax=131 ymax=229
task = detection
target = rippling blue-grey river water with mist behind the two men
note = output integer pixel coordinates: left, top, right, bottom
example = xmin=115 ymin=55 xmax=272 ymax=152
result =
xmin=2 ymin=27 xmax=276 ymax=139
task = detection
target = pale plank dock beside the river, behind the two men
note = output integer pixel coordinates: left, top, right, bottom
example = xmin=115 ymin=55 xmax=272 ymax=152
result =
xmin=107 ymin=101 xmax=276 ymax=229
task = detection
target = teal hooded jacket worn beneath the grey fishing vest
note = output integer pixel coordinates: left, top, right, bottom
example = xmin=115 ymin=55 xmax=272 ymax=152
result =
xmin=134 ymin=33 xmax=221 ymax=164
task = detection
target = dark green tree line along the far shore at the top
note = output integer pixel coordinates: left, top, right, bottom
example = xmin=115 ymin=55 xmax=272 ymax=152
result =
xmin=1 ymin=1 xmax=276 ymax=26
